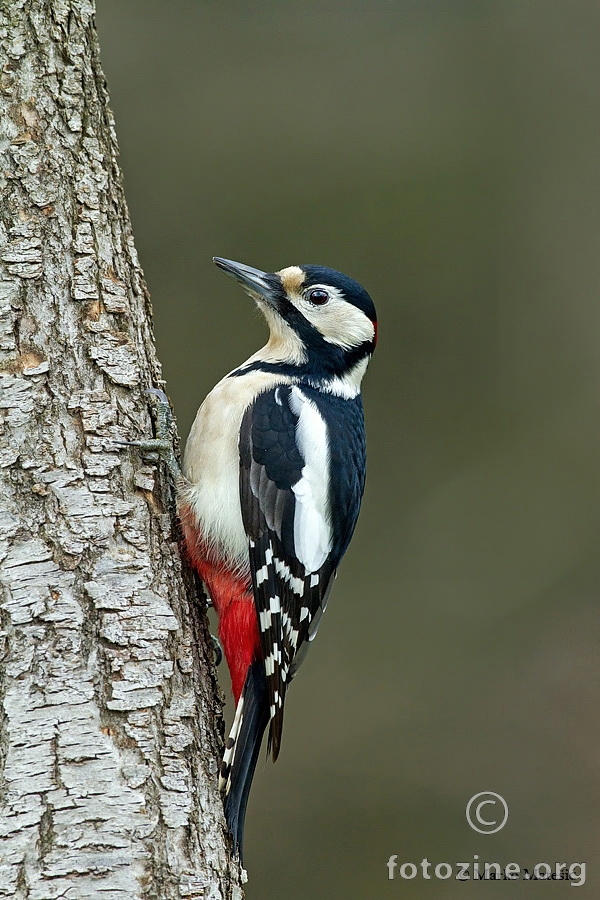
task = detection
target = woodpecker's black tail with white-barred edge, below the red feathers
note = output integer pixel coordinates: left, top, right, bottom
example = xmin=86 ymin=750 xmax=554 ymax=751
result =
xmin=219 ymin=660 xmax=269 ymax=860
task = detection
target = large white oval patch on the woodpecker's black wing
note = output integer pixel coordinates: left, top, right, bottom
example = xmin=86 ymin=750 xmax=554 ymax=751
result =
xmin=289 ymin=386 xmax=332 ymax=572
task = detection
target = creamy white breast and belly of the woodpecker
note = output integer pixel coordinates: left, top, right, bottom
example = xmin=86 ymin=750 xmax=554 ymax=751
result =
xmin=183 ymin=372 xmax=287 ymax=570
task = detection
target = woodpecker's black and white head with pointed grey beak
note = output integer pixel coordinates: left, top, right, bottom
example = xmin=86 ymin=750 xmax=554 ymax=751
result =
xmin=214 ymin=256 xmax=377 ymax=382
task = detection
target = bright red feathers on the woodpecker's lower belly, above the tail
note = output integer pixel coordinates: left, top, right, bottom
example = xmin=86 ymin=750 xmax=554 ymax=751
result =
xmin=179 ymin=504 xmax=260 ymax=704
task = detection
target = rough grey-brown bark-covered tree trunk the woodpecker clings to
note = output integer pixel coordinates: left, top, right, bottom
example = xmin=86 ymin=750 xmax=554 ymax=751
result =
xmin=0 ymin=0 xmax=242 ymax=900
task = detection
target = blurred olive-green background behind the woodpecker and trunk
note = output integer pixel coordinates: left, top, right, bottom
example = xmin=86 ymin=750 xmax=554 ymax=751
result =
xmin=98 ymin=0 xmax=600 ymax=900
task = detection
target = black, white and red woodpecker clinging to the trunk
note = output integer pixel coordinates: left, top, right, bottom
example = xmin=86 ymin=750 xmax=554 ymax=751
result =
xmin=129 ymin=257 xmax=377 ymax=856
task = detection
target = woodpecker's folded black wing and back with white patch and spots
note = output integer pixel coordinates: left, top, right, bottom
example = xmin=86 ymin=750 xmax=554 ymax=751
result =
xmin=240 ymin=385 xmax=365 ymax=759
